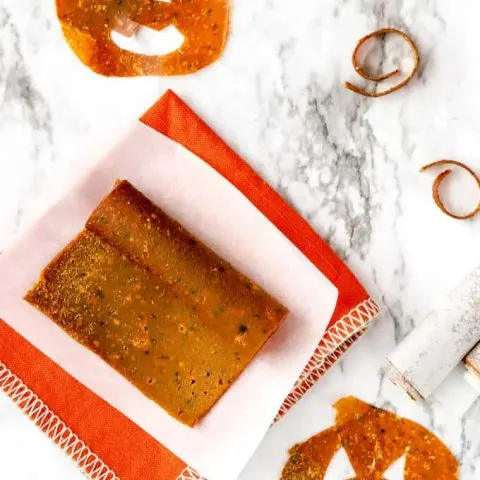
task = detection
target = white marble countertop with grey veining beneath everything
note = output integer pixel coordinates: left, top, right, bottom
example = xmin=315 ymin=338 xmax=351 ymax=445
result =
xmin=0 ymin=0 xmax=480 ymax=480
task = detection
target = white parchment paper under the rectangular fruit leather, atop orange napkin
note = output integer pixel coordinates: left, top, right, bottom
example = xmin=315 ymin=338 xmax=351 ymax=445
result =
xmin=0 ymin=122 xmax=338 ymax=480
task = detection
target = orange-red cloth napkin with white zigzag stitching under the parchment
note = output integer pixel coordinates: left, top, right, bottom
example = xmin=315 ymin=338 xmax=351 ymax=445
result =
xmin=0 ymin=91 xmax=379 ymax=480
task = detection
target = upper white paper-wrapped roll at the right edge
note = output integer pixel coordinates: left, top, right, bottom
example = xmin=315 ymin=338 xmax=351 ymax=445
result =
xmin=388 ymin=266 xmax=480 ymax=400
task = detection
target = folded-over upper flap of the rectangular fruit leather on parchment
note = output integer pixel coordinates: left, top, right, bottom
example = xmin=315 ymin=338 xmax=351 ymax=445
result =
xmin=87 ymin=181 xmax=286 ymax=344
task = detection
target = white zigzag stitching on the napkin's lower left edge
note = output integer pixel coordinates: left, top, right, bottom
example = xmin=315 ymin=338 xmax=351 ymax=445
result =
xmin=0 ymin=361 xmax=119 ymax=480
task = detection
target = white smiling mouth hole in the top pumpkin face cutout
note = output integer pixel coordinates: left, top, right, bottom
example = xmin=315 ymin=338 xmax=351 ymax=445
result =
xmin=111 ymin=24 xmax=184 ymax=55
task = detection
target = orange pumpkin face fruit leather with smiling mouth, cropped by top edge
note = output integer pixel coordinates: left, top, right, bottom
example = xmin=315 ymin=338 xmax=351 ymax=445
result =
xmin=57 ymin=0 xmax=229 ymax=77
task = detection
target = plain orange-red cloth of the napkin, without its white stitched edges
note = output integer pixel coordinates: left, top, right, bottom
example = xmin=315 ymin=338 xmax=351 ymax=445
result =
xmin=0 ymin=91 xmax=376 ymax=480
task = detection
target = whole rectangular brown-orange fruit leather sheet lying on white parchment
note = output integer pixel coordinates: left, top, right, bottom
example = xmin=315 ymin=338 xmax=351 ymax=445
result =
xmin=25 ymin=181 xmax=287 ymax=426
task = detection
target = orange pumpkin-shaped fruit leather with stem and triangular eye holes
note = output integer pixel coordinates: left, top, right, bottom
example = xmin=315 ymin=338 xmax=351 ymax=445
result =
xmin=281 ymin=397 xmax=458 ymax=480
